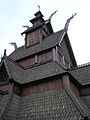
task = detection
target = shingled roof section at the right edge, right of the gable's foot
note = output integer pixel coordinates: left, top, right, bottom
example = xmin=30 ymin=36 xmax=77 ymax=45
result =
xmin=70 ymin=65 xmax=90 ymax=85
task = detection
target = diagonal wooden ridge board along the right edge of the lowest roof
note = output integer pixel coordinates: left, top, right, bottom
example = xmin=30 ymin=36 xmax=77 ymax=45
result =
xmin=65 ymin=88 xmax=88 ymax=118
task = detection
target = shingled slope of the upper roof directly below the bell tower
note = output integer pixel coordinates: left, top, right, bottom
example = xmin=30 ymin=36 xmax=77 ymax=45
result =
xmin=9 ymin=30 xmax=63 ymax=60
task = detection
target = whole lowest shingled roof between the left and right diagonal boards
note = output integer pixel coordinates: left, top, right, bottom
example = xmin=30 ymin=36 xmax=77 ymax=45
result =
xmin=0 ymin=89 xmax=88 ymax=120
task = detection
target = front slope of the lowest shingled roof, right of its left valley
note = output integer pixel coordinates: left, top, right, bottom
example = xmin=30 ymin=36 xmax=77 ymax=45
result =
xmin=18 ymin=89 xmax=83 ymax=120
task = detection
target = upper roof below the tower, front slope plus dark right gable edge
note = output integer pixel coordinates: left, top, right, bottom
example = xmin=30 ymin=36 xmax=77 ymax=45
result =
xmin=9 ymin=30 xmax=77 ymax=66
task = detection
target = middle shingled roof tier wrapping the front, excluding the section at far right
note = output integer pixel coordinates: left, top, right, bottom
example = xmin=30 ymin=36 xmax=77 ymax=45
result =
xmin=6 ymin=60 xmax=66 ymax=84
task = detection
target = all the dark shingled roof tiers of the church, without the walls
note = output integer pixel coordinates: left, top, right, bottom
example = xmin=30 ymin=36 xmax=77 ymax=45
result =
xmin=0 ymin=11 xmax=90 ymax=120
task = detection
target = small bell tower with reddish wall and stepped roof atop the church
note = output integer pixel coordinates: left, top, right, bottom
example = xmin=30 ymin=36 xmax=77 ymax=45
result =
xmin=21 ymin=11 xmax=53 ymax=48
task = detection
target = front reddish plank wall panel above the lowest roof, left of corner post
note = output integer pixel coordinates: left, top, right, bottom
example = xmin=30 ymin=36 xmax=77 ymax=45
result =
xmin=22 ymin=79 xmax=62 ymax=96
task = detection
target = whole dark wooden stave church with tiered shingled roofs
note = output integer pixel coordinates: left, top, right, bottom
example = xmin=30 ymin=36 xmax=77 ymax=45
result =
xmin=0 ymin=11 xmax=90 ymax=120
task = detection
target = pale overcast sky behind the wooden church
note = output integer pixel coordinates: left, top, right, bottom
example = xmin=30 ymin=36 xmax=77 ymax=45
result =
xmin=0 ymin=0 xmax=90 ymax=64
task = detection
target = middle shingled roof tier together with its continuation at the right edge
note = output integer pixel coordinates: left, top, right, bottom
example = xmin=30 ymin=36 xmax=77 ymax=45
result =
xmin=2 ymin=57 xmax=90 ymax=85
